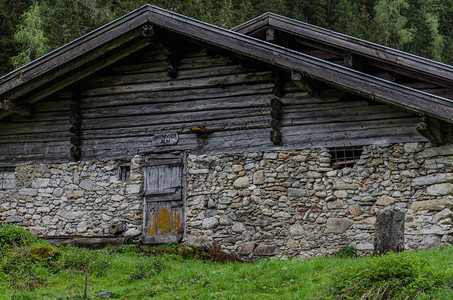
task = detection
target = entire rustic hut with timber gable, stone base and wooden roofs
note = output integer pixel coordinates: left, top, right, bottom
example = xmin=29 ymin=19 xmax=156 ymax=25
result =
xmin=0 ymin=5 xmax=453 ymax=256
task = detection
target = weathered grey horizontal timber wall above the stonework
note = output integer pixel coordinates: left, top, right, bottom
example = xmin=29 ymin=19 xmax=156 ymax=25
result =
xmin=0 ymin=46 xmax=424 ymax=165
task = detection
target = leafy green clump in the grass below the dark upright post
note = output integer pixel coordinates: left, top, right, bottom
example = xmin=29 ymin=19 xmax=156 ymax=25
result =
xmin=329 ymin=252 xmax=448 ymax=299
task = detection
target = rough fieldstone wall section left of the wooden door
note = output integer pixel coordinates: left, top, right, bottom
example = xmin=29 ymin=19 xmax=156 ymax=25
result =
xmin=0 ymin=156 xmax=143 ymax=237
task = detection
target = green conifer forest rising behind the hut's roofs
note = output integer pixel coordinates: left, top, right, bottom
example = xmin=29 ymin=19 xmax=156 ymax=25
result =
xmin=0 ymin=0 xmax=453 ymax=75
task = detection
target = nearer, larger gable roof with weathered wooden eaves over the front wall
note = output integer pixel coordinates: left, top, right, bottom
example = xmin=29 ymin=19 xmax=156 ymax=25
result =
xmin=0 ymin=5 xmax=453 ymax=123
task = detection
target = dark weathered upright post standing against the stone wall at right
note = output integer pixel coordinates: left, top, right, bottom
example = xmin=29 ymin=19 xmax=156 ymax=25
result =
xmin=374 ymin=208 xmax=405 ymax=255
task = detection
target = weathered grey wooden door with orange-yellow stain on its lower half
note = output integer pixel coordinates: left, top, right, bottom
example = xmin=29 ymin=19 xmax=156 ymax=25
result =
xmin=143 ymin=155 xmax=185 ymax=244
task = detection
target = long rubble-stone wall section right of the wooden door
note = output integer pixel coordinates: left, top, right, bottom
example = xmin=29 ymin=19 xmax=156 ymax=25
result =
xmin=185 ymin=143 xmax=453 ymax=257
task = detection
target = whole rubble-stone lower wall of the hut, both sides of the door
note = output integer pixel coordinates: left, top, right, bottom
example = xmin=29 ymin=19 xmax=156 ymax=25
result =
xmin=0 ymin=143 xmax=453 ymax=257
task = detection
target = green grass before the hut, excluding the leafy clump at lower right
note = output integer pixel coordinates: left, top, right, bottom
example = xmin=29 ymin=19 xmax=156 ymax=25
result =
xmin=0 ymin=226 xmax=453 ymax=299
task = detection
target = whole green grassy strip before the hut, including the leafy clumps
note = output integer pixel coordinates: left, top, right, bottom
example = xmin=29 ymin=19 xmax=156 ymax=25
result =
xmin=0 ymin=226 xmax=453 ymax=300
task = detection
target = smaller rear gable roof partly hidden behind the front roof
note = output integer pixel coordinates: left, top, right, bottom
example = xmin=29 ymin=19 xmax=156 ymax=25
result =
xmin=232 ymin=13 xmax=453 ymax=99
